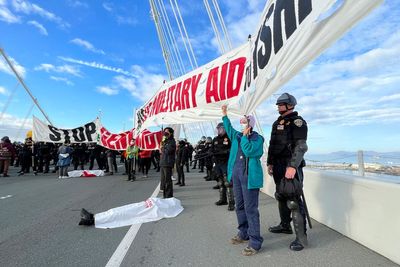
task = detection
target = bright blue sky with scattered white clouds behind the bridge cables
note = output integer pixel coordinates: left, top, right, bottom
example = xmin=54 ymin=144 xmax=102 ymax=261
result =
xmin=0 ymin=0 xmax=400 ymax=153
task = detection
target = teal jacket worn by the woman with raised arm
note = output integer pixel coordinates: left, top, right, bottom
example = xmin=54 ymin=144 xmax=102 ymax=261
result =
xmin=222 ymin=116 xmax=264 ymax=189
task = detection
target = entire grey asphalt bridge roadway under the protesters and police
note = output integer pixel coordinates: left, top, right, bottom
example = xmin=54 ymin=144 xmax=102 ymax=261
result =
xmin=0 ymin=166 xmax=397 ymax=267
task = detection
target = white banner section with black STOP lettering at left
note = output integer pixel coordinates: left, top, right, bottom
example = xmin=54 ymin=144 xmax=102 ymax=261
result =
xmin=32 ymin=116 xmax=100 ymax=143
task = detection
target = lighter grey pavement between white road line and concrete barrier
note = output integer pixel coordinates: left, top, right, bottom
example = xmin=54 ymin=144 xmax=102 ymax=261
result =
xmin=121 ymin=170 xmax=398 ymax=266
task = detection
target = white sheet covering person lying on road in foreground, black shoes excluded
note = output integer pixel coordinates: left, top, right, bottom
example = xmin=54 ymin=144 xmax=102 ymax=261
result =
xmin=94 ymin=197 xmax=183 ymax=229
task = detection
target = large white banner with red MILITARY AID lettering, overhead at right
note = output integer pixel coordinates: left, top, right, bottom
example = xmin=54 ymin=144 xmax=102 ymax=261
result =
xmin=135 ymin=0 xmax=383 ymax=130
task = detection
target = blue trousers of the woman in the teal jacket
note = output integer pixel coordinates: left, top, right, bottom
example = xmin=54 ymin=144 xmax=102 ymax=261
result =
xmin=232 ymin=168 xmax=264 ymax=250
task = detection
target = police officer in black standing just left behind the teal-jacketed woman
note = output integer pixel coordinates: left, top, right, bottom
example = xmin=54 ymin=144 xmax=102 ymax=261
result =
xmin=211 ymin=122 xmax=235 ymax=210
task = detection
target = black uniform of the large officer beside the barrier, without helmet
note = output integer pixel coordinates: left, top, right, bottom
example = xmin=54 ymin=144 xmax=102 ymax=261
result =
xmin=267 ymin=112 xmax=307 ymax=251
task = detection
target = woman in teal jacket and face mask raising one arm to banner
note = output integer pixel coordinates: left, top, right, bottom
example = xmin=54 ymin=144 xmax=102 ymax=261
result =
xmin=222 ymin=105 xmax=264 ymax=256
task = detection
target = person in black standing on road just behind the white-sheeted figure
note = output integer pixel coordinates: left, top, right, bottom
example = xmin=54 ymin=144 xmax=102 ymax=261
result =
xmin=160 ymin=127 xmax=176 ymax=198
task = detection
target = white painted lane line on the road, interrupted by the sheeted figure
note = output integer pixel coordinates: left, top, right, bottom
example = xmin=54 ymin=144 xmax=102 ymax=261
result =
xmin=106 ymin=184 xmax=160 ymax=267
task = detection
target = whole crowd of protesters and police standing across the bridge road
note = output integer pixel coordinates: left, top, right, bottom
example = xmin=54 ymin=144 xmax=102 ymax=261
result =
xmin=0 ymin=93 xmax=308 ymax=256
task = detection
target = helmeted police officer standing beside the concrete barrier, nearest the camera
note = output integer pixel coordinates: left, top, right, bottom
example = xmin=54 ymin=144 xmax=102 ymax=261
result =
xmin=267 ymin=93 xmax=307 ymax=251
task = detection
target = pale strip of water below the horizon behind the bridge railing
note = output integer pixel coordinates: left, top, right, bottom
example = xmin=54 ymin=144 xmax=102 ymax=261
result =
xmin=305 ymin=151 xmax=400 ymax=166
